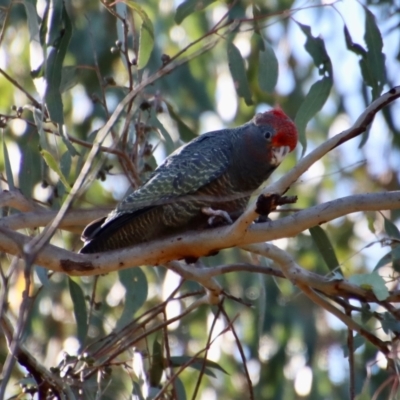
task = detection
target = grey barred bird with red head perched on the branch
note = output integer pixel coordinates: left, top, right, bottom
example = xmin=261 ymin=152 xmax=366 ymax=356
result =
xmin=80 ymin=108 xmax=298 ymax=254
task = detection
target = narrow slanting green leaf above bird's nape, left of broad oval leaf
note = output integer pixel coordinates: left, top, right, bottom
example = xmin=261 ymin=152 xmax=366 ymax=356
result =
xmin=228 ymin=42 xmax=253 ymax=106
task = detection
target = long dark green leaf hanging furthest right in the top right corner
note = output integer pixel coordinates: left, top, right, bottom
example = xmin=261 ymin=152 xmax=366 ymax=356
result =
xmin=364 ymin=7 xmax=386 ymax=97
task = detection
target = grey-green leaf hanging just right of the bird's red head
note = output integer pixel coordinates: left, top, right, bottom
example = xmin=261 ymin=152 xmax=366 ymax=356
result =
xmin=294 ymin=77 xmax=333 ymax=154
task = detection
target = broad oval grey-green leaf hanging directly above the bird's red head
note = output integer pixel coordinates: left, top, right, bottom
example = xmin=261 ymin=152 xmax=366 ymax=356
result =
xmin=258 ymin=40 xmax=279 ymax=93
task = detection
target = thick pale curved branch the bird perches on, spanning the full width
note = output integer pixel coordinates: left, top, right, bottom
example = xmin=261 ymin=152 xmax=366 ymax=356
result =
xmin=0 ymin=191 xmax=400 ymax=275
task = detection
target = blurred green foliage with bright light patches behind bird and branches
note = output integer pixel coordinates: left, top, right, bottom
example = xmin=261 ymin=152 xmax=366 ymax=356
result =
xmin=0 ymin=0 xmax=400 ymax=400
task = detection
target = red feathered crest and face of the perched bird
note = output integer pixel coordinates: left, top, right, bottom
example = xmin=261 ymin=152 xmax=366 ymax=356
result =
xmin=253 ymin=108 xmax=298 ymax=151
